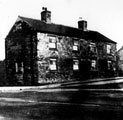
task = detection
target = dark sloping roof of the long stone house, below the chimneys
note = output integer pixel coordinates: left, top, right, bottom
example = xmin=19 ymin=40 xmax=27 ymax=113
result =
xmin=7 ymin=16 xmax=116 ymax=44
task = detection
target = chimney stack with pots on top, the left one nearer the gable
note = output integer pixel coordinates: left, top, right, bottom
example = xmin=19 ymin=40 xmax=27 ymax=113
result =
xmin=41 ymin=7 xmax=51 ymax=23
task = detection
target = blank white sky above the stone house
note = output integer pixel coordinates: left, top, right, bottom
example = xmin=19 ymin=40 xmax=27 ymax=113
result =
xmin=0 ymin=0 xmax=123 ymax=60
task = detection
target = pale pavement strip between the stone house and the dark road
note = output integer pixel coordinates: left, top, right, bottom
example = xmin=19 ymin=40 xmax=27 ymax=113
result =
xmin=0 ymin=77 xmax=123 ymax=92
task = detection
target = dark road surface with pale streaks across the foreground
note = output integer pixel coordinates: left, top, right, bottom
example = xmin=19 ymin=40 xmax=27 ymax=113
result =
xmin=0 ymin=77 xmax=123 ymax=120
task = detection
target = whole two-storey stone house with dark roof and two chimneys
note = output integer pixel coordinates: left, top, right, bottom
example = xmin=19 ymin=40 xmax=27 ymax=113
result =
xmin=5 ymin=8 xmax=116 ymax=85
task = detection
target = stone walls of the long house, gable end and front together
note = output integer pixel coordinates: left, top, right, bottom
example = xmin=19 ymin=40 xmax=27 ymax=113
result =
xmin=5 ymin=22 xmax=116 ymax=85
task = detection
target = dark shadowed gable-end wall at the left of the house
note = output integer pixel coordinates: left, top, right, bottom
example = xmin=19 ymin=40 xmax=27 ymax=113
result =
xmin=5 ymin=22 xmax=37 ymax=85
